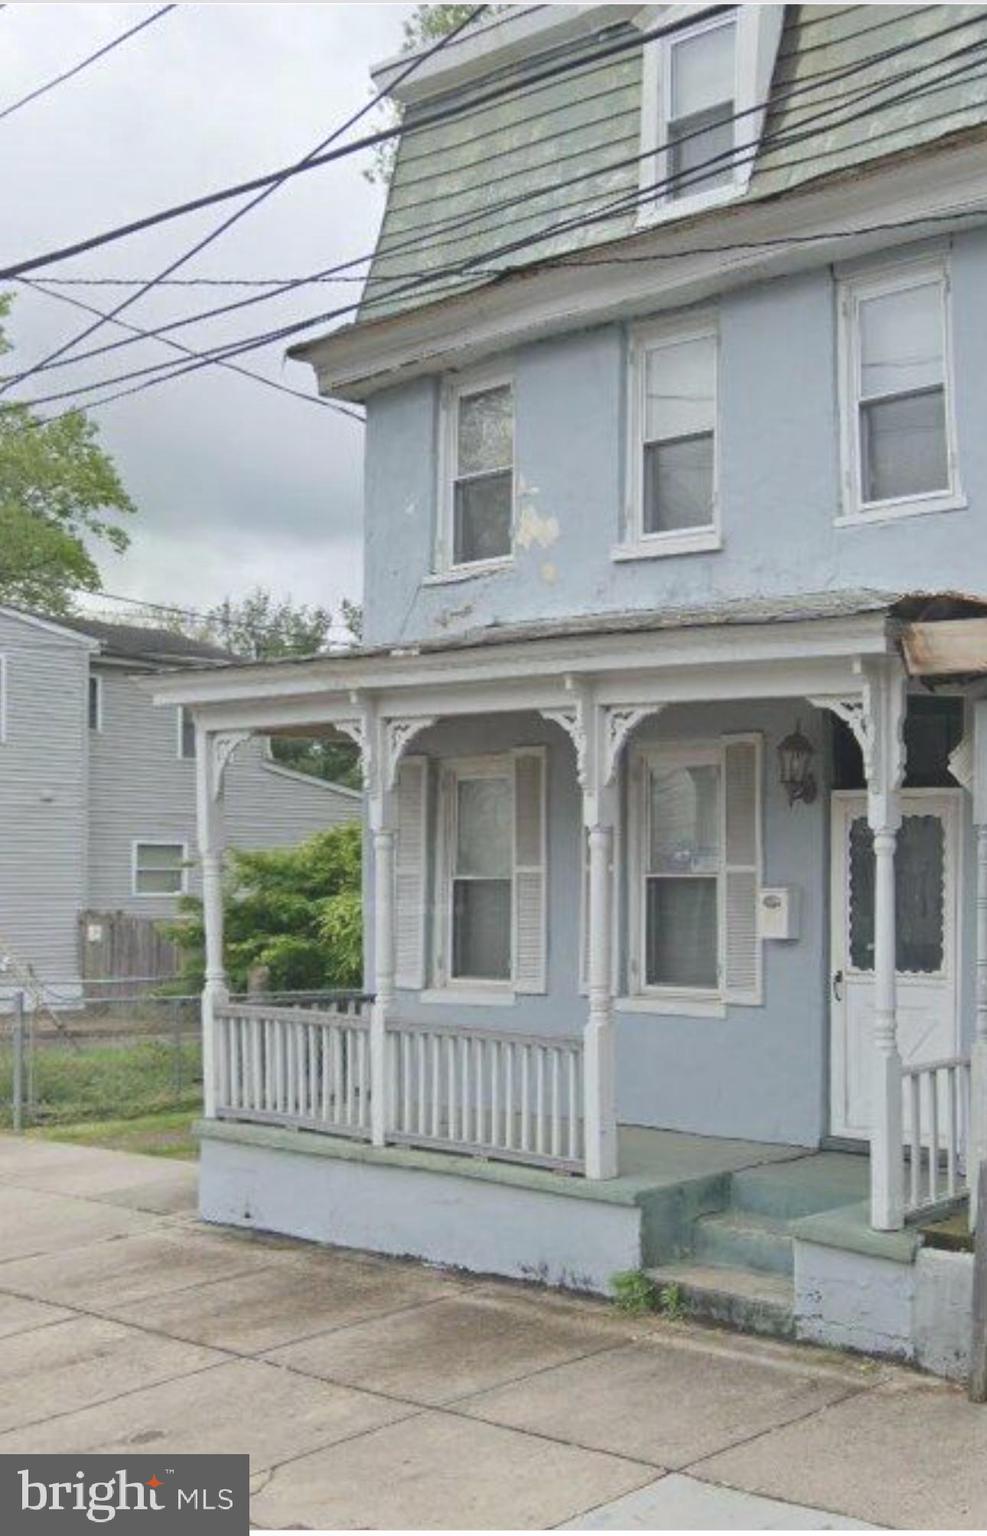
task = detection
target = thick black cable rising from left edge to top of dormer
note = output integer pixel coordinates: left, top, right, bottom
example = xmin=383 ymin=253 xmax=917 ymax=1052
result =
xmin=0 ymin=5 xmax=734 ymax=280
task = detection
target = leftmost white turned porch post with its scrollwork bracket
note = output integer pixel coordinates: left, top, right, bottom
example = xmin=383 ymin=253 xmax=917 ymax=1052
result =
xmin=195 ymin=722 xmax=253 ymax=1120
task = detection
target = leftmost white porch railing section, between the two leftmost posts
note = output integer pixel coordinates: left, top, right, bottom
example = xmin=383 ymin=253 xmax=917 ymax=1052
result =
xmin=213 ymin=1000 xmax=370 ymax=1140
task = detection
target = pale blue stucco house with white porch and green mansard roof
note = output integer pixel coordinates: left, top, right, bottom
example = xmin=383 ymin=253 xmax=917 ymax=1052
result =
xmin=157 ymin=5 xmax=987 ymax=1370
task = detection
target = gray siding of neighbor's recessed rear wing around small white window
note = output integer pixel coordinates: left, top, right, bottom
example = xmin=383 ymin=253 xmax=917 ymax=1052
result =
xmin=87 ymin=664 xmax=361 ymax=919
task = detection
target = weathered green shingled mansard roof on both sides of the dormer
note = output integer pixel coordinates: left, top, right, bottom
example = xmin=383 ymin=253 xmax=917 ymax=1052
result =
xmin=354 ymin=5 xmax=987 ymax=321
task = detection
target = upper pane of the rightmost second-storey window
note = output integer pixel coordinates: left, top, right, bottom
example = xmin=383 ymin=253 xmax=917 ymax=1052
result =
xmin=860 ymin=283 xmax=942 ymax=396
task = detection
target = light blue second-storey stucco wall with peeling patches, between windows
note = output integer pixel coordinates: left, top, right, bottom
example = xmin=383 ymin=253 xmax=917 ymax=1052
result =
xmin=365 ymin=233 xmax=987 ymax=642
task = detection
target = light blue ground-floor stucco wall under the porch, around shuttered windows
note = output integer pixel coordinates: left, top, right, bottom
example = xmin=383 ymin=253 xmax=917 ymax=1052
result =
xmin=382 ymin=702 xmax=829 ymax=1146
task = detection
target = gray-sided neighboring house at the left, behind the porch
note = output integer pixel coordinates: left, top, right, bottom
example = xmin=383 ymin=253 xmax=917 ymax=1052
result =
xmin=0 ymin=607 xmax=361 ymax=1003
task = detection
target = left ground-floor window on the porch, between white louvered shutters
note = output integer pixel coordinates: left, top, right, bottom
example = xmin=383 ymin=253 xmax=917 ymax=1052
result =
xmin=451 ymin=766 xmax=514 ymax=982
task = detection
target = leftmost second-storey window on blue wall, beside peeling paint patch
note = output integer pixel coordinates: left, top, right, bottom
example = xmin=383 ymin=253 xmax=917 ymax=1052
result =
xmin=450 ymin=381 xmax=514 ymax=565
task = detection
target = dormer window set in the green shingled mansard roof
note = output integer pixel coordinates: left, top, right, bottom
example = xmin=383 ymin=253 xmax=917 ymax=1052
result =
xmin=660 ymin=20 xmax=737 ymax=198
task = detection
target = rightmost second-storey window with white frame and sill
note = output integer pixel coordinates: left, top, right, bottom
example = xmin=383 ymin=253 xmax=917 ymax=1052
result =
xmin=843 ymin=266 xmax=955 ymax=513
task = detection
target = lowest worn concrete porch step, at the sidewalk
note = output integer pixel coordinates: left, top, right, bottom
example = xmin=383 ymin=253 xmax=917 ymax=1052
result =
xmin=646 ymin=1263 xmax=795 ymax=1338
